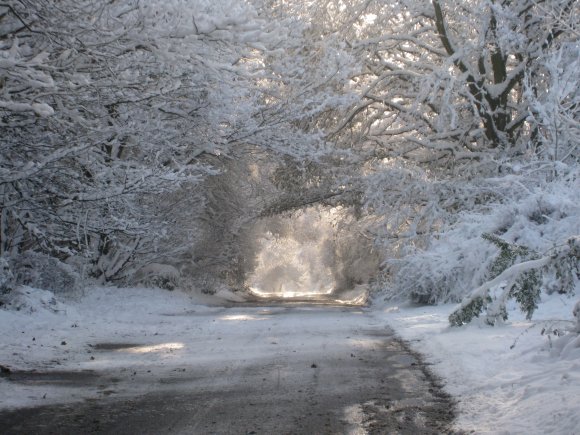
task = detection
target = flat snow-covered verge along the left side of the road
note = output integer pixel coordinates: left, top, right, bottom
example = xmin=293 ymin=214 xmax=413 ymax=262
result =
xmin=0 ymin=286 xmax=231 ymax=408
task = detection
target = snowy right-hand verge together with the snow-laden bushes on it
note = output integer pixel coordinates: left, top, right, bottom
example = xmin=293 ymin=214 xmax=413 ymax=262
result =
xmin=377 ymin=169 xmax=580 ymax=434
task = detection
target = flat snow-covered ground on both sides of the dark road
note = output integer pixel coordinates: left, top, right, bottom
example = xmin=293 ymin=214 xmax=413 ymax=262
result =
xmin=0 ymin=288 xmax=580 ymax=434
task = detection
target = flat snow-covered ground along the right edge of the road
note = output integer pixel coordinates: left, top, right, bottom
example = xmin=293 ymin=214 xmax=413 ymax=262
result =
xmin=377 ymin=294 xmax=580 ymax=435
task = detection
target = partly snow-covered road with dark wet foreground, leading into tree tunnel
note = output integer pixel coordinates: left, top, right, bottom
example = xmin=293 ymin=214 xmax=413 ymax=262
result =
xmin=0 ymin=304 xmax=453 ymax=435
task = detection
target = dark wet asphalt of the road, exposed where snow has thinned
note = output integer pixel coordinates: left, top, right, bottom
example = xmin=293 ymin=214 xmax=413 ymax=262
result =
xmin=0 ymin=304 xmax=454 ymax=435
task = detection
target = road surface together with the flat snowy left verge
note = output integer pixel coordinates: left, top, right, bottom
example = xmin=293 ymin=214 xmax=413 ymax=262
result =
xmin=0 ymin=289 xmax=453 ymax=434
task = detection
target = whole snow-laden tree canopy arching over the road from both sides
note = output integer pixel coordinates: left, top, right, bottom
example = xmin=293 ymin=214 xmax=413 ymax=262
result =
xmin=0 ymin=0 xmax=580 ymax=314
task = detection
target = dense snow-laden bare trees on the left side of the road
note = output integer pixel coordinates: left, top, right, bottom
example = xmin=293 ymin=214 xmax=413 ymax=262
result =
xmin=0 ymin=0 xmax=288 ymax=280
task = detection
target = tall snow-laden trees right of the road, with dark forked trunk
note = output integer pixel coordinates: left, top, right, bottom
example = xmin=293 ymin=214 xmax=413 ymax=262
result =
xmin=250 ymin=0 xmax=579 ymax=302
